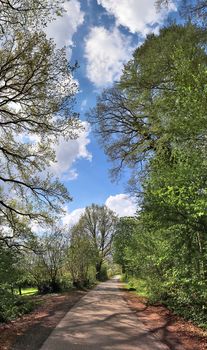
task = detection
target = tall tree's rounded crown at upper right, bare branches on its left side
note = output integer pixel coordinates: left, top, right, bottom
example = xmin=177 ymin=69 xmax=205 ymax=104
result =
xmin=88 ymin=24 xmax=206 ymax=179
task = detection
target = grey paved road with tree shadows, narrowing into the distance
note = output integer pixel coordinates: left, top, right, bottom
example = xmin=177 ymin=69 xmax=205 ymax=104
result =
xmin=40 ymin=279 xmax=169 ymax=350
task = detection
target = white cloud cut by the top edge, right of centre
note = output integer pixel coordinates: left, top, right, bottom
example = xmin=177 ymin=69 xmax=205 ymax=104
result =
xmin=97 ymin=0 xmax=176 ymax=36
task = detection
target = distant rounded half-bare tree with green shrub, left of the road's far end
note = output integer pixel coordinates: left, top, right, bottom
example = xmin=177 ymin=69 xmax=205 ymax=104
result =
xmin=67 ymin=204 xmax=117 ymax=287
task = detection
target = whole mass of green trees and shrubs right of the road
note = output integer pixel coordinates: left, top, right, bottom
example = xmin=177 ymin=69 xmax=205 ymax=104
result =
xmin=88 ymin=1 xmax=207 ymax=325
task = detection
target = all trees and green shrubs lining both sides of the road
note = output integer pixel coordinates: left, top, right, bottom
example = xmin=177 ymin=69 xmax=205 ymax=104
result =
xmin=0 ymin=0 xmax=207 ymax=327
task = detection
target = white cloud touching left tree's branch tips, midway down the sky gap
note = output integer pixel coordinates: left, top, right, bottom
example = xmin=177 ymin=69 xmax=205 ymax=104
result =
xmin=51 ymin=122 xmax=92 ymax=180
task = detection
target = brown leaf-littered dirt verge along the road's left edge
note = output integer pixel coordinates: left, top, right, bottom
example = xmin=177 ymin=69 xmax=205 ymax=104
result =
xmin=0 ymin=290 xmax=86 ymax=350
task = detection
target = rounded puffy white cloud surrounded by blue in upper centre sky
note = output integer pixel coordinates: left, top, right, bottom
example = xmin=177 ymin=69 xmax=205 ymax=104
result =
xmin=85 ymin=27 xmax=134 ymax=87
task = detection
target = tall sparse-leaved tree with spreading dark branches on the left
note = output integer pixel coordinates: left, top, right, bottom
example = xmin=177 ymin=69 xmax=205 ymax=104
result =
xmin=0 ymin=0 xmax=80 ymax=244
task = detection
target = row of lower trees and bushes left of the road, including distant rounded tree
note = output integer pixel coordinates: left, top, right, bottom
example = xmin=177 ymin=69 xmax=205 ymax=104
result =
xmin=0 ymin=204 xmax=118 ymax=322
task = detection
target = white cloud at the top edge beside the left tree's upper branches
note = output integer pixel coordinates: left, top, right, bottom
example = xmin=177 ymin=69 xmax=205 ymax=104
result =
xmin=46 ymin=0 xmax=84 ymax=54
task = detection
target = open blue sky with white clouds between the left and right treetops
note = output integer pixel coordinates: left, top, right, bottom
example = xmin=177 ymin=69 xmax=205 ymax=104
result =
xmin=47 ymin=0 xmax=176 ymax=224
